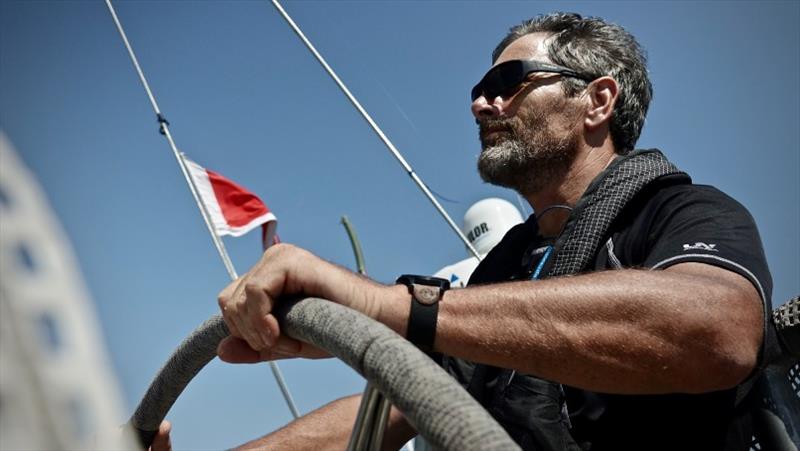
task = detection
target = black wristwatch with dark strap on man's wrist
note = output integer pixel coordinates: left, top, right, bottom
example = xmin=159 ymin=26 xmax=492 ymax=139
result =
xmin=395 ymin=274 xmax=450 ymax=352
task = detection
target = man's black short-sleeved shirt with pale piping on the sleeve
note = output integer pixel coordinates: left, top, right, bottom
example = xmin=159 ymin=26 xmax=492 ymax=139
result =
xmin=444 ymin=176 xmax=772 ymax=450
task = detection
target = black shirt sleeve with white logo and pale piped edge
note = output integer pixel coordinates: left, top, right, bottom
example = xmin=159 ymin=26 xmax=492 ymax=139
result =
xmin=643 ymin=185 xmax=772 ymax=311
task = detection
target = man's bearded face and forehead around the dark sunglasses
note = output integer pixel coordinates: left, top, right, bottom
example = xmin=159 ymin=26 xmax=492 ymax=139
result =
xmin=472 ymin=33 xmax=580 ymax=195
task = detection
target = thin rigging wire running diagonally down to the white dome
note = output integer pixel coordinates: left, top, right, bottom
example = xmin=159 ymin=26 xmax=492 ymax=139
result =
xmin=271 ymin=0 xmax=481 ymax=261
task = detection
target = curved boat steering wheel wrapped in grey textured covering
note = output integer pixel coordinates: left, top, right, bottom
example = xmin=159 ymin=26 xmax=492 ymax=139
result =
xmin=129 ymin=298 xmax=520 ymax=451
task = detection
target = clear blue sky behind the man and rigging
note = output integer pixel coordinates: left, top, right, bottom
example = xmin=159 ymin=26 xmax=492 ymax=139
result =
xmin=0 ymin=0 xmax=800 ymax=449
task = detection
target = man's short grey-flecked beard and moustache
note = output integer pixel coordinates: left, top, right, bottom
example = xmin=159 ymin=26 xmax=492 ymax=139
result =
xmin=478 ymin=130 xmax=577 ymax=196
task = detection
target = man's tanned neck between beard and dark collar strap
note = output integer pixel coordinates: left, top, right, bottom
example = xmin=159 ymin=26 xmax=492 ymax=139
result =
xmin=525 ymin=146 xmax=616 ymax=237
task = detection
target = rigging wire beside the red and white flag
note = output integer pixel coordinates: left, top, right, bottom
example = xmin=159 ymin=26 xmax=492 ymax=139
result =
xmin=101 ymin=0 xmax=300 ymax=418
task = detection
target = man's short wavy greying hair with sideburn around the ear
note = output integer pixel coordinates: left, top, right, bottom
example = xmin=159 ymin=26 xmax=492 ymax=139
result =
xmin=492 ymin=12 xmax=653 ymax=154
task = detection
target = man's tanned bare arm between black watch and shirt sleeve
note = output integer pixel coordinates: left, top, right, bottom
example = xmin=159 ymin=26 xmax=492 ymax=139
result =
xmin=381 ymin=263 xmax=762 ymax=393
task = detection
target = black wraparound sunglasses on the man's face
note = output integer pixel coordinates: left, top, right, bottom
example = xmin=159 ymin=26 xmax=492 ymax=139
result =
xmin=472 ymin=60 xmax=591 ymax=102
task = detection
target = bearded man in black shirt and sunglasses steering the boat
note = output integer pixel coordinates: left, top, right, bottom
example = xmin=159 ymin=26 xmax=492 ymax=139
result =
xmin=211 ymin=13 xmax=771 ymax=450
